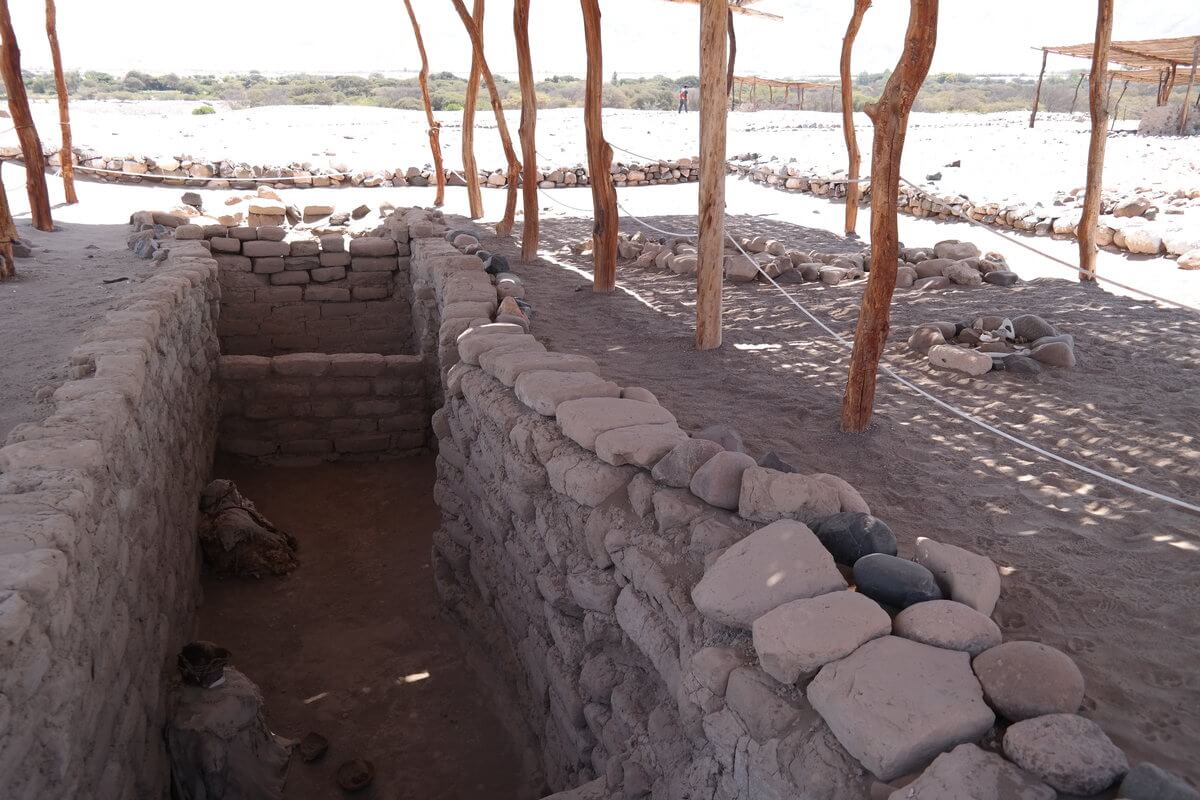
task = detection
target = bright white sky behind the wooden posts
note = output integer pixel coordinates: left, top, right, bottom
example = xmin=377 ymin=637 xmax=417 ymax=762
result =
xmin=10 ymin=0 xmax=1200 ymax=79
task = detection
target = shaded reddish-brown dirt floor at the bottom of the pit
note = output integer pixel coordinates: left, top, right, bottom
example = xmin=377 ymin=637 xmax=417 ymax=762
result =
xmin=200 ymin=457 xmax=540 ymax=800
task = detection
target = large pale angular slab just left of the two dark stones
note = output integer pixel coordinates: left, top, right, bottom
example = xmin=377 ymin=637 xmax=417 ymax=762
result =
xmin=691 ymin=519 xmax=849 ymax=633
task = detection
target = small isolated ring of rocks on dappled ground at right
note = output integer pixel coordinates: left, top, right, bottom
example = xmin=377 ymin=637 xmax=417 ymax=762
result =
xmin=908 ymin=314 xmax=1075 ymax=375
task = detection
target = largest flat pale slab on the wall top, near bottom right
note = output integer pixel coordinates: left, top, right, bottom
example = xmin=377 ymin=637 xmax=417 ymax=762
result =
xmin=808 ymin=636 xmax=996 ymax=781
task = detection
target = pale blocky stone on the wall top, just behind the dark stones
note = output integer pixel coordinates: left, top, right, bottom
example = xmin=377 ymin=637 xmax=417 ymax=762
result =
xmin=738 ymin=467 xmax=871 ymax=523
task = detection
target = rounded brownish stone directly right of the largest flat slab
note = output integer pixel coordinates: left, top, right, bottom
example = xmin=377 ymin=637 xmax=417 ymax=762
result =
xmin=972 ymin=642 xmax=1084 ymax=722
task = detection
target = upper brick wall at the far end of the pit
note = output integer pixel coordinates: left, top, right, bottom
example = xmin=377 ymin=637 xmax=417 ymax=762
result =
xmin=183 ymin=225 xmax=413 ymax=356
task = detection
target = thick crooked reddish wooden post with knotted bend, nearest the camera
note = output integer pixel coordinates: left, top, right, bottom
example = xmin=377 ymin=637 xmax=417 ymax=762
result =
xmin=841 ymin=0 xmax=937 ymax=433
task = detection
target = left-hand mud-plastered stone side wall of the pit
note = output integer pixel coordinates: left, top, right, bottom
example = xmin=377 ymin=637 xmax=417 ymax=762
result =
xmin=0 ymin=243 xmax=220 ymax=800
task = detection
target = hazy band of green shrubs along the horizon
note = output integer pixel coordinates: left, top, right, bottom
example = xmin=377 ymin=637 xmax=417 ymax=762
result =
xmin=11 ymin=71 xmax=1156 ymax=118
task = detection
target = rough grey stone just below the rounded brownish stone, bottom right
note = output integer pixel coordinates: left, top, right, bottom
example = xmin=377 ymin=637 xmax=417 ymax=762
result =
xmin=1004 ymin=714 xmax=1129 ymax=795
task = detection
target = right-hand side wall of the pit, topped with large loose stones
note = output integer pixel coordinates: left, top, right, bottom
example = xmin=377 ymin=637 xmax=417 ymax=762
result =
xmin=412 ymin=212 xmax=1156 ymax=800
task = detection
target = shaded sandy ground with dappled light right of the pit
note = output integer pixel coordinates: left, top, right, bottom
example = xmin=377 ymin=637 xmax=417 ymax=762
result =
xmin=484 ymin=216 xmax=1200 ymax=781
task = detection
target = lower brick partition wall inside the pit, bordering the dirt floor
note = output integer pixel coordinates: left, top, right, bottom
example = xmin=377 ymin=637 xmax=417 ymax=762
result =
xmin=218 ymin=353 xmax=430 ymax=462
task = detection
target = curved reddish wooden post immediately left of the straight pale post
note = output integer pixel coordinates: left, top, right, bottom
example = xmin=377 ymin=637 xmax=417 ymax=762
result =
xmin=580 ymin=0 xmax=619 ymax=291
